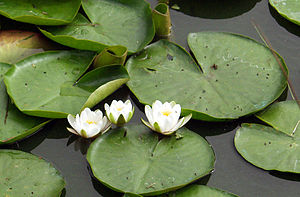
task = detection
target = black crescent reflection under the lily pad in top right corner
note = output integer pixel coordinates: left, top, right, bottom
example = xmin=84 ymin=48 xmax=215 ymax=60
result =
xmin=269 ymin=4 xmax=300 ymax=37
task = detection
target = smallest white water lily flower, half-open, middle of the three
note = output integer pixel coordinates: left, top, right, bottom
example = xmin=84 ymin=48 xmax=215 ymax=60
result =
xmin=104 ymin=100 xmax=134 ymax=126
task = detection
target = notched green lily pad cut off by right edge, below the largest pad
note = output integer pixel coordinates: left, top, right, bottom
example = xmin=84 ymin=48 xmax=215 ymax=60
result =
xmin=234 ymin=101 xmax=300 ymax=173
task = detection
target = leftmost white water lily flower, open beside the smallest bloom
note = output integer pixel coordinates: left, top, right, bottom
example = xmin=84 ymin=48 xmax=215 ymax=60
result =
xmin=67 ymin=108 xmax=111 ymax=138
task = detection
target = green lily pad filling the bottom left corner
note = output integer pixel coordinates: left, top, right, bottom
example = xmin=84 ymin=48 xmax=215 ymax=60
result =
xmin=0 ymin=149 xmax=65 ymax=197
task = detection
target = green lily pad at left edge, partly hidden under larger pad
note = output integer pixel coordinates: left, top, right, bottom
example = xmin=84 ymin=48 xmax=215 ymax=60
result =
xmin=0 ymin=63 xmax=48 ymax=145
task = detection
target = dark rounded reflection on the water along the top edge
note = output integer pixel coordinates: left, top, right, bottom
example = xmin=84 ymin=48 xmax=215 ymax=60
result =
xmin=170 ymin=0 xmax=261 ymax=19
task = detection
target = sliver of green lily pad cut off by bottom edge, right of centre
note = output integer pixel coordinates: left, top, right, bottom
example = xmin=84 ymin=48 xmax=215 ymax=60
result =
xmin=161 ymin=185 xmax=237 ymax=197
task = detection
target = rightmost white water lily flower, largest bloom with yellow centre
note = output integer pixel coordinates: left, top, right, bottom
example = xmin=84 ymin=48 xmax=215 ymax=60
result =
xmin=142 ymin=100 xmax=192 ymax=135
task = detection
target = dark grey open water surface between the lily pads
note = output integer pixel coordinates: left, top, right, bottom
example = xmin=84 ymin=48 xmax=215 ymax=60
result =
xmin=1 ymin=0 xmax=300 ymax=197
